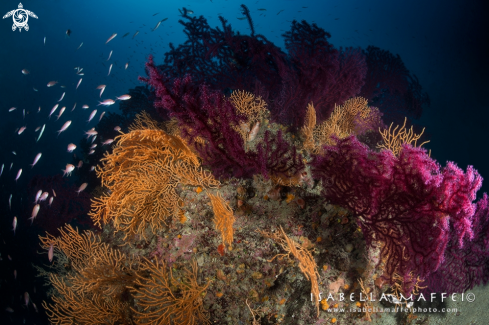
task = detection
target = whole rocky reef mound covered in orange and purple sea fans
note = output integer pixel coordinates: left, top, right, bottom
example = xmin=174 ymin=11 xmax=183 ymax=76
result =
xmin=30 ymin=5 xmax=489 ymax=324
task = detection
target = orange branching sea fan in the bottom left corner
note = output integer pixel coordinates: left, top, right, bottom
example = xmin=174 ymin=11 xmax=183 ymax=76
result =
xmin=40 ymin=225 xmax=136 ymax=324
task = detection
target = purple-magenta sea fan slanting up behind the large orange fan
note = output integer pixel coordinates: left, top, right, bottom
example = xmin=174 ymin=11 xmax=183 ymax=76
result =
xmin=140 ymin=56 xmax=304 ymax=178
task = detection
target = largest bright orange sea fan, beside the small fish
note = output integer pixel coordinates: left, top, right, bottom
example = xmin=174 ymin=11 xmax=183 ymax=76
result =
xmin=90 ymin=114 xmax=219 ymax=238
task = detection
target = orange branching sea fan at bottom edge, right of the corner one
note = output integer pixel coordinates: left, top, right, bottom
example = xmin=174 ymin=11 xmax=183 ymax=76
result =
xmin=132 ymin=260 xmax=210 ymax=325
